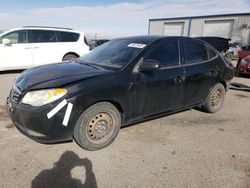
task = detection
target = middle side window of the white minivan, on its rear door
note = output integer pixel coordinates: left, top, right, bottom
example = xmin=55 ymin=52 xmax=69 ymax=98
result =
xmin=30 ymin=30 xmax=56 ymax=42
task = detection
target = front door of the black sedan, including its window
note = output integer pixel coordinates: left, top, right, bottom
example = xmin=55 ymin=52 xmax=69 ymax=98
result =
xmin=134 ymin=38 xmax=184 ymax=116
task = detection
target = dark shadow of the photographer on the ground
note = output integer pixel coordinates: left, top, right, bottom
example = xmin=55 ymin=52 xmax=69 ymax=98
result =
xmin=31 ymin=151 xmax=97 ymax=188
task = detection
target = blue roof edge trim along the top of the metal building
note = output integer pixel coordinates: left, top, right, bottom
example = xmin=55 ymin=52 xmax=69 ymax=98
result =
xmin=149 ymin=12 xmax=250 ymax=21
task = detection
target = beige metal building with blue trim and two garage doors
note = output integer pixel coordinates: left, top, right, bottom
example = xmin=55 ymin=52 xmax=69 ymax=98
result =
xmin=148 ymin=13 xmax=250 ymax=44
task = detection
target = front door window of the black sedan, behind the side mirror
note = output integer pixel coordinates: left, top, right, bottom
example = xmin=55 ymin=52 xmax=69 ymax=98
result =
xmin=144 ymin=40 xmax=179 ymax=66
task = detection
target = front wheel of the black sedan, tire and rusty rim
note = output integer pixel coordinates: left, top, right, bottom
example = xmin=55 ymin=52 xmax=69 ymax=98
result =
xmin=73 ymin=102 xmax=121 ymax=151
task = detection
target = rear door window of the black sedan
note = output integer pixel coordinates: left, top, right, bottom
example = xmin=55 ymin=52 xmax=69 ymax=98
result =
xmin=183 ymin=39 xmax=208 ymax=64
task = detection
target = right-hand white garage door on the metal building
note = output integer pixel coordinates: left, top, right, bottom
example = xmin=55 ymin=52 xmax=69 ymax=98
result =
xmin=202 ymin=20 xmax=233 ymax=39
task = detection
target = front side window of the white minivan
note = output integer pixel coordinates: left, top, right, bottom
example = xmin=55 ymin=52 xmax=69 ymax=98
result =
xmin=2 ymin=30 xmax=28 ymax=44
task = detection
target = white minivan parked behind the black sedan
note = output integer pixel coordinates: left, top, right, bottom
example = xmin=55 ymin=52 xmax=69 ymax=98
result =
xmin=0 ymin=26 xmax=89 ymax=71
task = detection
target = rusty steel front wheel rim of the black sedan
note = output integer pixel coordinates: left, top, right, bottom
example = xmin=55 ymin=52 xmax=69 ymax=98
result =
xmin=87 ymin=113 xmax=113 ymax=141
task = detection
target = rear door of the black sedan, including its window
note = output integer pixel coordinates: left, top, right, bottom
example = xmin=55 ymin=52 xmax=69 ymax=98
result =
xmin=181 ymin=38 xmax=219 ymax=107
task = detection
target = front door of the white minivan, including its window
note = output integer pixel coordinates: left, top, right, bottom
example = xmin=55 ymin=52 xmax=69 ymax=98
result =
xmin=0 ymin=30 xmax=32 ymax=70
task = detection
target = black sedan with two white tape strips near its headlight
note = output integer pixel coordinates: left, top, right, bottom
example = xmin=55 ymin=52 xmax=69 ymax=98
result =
xmin=7 ymin=36 xmax=233 ymax=150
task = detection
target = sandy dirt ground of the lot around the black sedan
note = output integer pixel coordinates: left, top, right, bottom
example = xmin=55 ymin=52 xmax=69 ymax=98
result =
xmin=0 ymin=73 xmax=250 ymax=188
